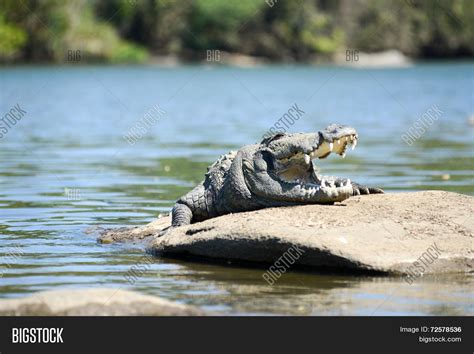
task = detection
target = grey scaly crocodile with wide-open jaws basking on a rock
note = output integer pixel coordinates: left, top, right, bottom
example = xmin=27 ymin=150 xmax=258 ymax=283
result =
xmin=166 ymin=124 xmax=383 ymax=231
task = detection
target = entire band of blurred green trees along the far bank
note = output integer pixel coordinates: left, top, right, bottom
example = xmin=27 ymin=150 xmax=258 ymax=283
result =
xmin=0 ymin=0 xmax=474 ymax=62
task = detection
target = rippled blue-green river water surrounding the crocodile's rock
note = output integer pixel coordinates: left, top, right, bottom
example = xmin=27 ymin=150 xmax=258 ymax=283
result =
xmin=0 ymin=63 xmax=474 ymax=315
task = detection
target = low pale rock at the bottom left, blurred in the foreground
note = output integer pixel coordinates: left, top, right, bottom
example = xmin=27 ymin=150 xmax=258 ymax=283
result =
xmin=0 ymin=288 xmax=204 ymax=316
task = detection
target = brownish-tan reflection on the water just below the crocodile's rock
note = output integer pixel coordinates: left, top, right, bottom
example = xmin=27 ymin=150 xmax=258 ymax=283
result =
xmin=150 ymin=263 xmax=472 ymax=316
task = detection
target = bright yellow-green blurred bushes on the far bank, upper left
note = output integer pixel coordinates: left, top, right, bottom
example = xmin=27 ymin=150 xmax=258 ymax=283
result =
xmin=0 ymin=0 xmax=147 ymax=62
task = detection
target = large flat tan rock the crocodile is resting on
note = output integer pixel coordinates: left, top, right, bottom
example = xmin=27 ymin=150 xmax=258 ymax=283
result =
xmin=100 ymin=191 xmax=474 ymax=275
